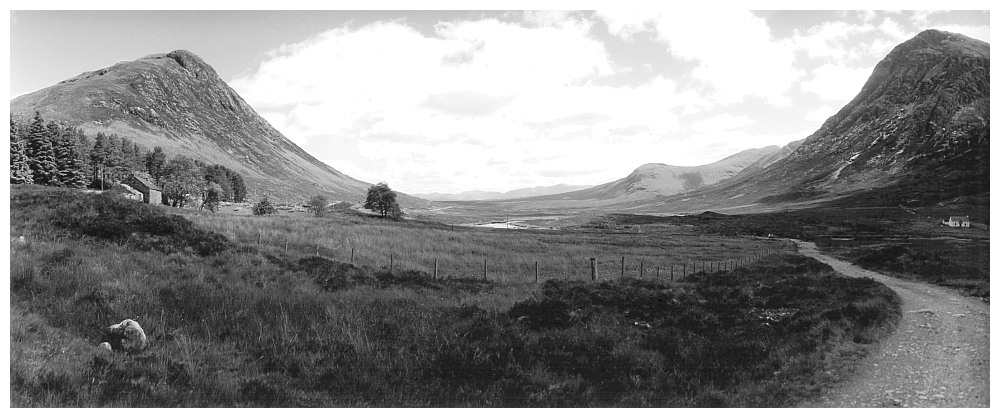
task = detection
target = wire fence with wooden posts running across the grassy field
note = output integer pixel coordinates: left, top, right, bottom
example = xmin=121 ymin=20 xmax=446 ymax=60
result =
xmin=244 ymin=229 xmax=780 ymax=283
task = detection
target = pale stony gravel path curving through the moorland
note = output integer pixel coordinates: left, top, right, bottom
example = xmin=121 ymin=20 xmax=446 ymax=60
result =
xmin=796 ymin=241 xmax=990 ymax=408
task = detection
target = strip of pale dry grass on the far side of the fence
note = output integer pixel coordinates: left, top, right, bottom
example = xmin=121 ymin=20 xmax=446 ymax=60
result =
xmin=178 ymin=207 xmax=790 ymax=283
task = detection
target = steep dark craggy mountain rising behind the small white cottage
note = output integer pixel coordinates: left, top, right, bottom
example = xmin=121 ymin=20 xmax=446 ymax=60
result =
xmin=618 ymin=30 xmax=990 ymax=213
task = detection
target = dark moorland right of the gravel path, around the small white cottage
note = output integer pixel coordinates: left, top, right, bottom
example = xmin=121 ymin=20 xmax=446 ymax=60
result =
xmin=586 ymin=204 xmax=990 ymax=300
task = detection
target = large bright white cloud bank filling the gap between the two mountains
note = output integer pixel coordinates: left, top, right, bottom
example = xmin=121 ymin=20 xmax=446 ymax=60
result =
xmin=230 ymin=9 xmax=948 ymax=193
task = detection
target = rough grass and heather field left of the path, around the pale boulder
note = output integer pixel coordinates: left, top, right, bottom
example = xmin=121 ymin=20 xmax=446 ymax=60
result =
xmin=10 ymin=186 xmax=899 ymax=407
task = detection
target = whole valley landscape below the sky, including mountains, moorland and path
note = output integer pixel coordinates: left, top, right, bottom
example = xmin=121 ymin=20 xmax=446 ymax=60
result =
xmin=9 ymin=21 xmax=990 ymax=408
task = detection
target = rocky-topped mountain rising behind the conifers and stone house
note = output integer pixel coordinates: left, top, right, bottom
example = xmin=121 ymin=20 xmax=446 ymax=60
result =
xmin=10 ymin=50 xmax=419 ymax=204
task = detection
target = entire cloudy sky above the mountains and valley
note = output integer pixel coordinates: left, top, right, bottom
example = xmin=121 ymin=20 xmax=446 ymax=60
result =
xmin=9 ymin=3 xmax=990 ymax=193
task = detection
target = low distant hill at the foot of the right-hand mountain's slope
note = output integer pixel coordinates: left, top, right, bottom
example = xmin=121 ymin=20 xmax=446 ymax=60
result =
xmin=536 ymin=145 xmax=782 ymax=201
